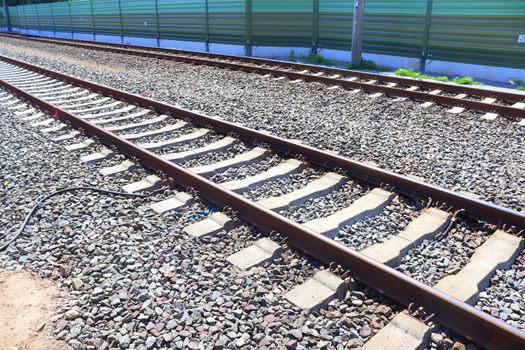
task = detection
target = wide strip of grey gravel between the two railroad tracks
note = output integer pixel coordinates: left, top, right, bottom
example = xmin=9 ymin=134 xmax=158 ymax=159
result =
xmin=0 ymin=38 xmax=525 ymax=213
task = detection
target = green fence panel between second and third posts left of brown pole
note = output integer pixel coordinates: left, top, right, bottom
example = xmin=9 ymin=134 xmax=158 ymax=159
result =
xmin=208 ymin=0 xmax=245 ymax=45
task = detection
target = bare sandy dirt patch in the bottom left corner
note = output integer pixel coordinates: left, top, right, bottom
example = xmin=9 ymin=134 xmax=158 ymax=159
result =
xmin=0 ymin=272 xmax=70 ymax=350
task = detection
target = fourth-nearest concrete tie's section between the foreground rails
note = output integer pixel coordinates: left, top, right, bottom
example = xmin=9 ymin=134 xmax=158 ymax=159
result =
xmin=257 ymin=173 xmax=345 ymax=211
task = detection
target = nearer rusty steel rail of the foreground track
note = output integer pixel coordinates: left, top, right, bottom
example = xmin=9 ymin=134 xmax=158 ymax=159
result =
xmin=0 ymin=66 xmax=525 ymax=349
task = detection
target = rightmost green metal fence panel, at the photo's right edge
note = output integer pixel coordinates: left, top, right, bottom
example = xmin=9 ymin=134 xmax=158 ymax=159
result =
xmin=428 ymin=0 xmax=525 ymax=69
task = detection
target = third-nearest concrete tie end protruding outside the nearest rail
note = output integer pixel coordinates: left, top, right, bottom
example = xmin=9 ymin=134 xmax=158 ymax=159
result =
xmin=226 ymin=237 xmax=282 ymax=270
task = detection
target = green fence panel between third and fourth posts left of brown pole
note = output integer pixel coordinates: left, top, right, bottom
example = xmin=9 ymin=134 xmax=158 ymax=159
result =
xmin=158 ymin=0 xmax=206 ymax=41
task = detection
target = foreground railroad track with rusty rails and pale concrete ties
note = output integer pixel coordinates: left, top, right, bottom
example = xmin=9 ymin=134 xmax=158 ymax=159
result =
xmin=0 ymin=56 xmax=525 ymax=349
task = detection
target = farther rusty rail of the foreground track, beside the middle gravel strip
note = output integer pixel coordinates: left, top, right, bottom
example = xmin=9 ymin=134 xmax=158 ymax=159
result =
xmin=0 ymin=55 xmax=525 ymax=228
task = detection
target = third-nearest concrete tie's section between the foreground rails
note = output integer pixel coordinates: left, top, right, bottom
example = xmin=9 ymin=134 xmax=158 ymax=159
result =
xmin=303 ymin=188 xmax=394 ymax=239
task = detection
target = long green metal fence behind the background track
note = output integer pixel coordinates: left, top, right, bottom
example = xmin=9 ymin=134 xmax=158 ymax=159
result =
xmin=1 ymin=0 xmax=525 ymax=68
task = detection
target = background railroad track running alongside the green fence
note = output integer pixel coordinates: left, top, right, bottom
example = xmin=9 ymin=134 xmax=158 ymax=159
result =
xmin=0 ymin=33 xmax=525 ymax=125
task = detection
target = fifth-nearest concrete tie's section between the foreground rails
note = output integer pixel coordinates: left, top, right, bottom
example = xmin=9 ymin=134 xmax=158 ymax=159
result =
xmin=219 ymin=159 xmax=305 ymax=193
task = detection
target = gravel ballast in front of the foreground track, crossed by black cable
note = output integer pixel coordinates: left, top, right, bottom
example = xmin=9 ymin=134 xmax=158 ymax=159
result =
xmin=0 ymin=104 xmax=406 ymax=349
